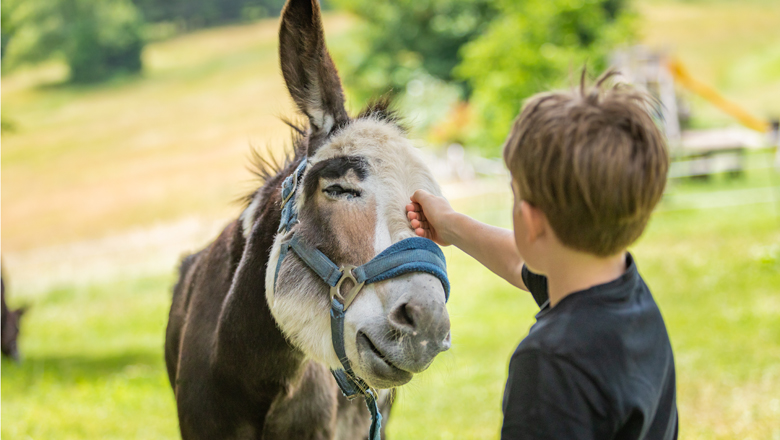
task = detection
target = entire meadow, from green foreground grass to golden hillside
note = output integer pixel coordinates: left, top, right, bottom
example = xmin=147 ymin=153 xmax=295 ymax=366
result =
xmin=0 ymin=0 xmax=780 ymax=440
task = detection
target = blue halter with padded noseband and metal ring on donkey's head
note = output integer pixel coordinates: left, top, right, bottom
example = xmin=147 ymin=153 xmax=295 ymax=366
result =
xmin=274 ymin=158 xmax=450 ymax=440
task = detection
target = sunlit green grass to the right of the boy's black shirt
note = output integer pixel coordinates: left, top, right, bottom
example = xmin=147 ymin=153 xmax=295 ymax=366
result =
xmin=636 ymin=204 xmax=780 ymax=439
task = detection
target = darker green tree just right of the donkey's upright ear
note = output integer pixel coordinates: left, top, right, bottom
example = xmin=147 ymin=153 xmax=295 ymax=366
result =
xmin=333 ymin=0 xmax=495 ymax=100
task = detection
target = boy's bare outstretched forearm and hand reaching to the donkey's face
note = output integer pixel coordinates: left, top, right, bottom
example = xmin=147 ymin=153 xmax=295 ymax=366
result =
xmin=406 ymin=190 xmax=528 ymax=290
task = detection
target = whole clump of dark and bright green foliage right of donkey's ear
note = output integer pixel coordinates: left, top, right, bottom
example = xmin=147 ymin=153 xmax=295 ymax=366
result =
xmin=326 ymin=0 xmax=633 ymax=154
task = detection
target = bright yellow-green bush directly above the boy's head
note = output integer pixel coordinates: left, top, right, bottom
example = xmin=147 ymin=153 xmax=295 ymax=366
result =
xmin=456 ymin=0 xmax=634 ymax=154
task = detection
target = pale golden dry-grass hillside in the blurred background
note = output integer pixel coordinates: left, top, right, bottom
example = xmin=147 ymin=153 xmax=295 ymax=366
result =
xmin=2 ymin=0 xmax=780 ymax=252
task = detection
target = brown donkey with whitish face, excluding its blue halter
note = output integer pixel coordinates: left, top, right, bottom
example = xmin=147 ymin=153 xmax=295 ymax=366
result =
xmin=165 ymin=0 xmax=450 ymax=440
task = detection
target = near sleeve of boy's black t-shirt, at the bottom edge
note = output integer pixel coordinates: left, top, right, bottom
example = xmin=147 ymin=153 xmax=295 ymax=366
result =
xmin=501 ymin=350 xmax=611 ymax=440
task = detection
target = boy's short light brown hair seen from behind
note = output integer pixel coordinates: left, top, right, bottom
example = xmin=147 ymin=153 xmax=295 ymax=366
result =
xmin=504 ymin=72 xmax=669 ymax=256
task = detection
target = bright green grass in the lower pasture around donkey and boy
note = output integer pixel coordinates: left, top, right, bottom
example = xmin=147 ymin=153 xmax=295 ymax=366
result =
xmin=2 ymin=183 xmax=780 ymax=439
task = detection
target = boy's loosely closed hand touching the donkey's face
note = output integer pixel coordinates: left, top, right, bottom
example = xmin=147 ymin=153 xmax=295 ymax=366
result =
xmin=406 ymin=189 xmax=455 ymax=246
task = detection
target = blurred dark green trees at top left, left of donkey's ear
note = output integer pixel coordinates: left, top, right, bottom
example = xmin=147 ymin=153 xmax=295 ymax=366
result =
xmin=1 ymin=0 xmax=284 ymax=83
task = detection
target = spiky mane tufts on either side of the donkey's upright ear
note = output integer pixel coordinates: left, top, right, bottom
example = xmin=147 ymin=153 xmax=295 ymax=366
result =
xmin=238 ymin=94 xmax=408 ymax=208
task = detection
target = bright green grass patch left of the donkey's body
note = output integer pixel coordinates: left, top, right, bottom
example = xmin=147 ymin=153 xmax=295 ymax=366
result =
xmin=2 ymin=277 xmax=178 ymax=439
